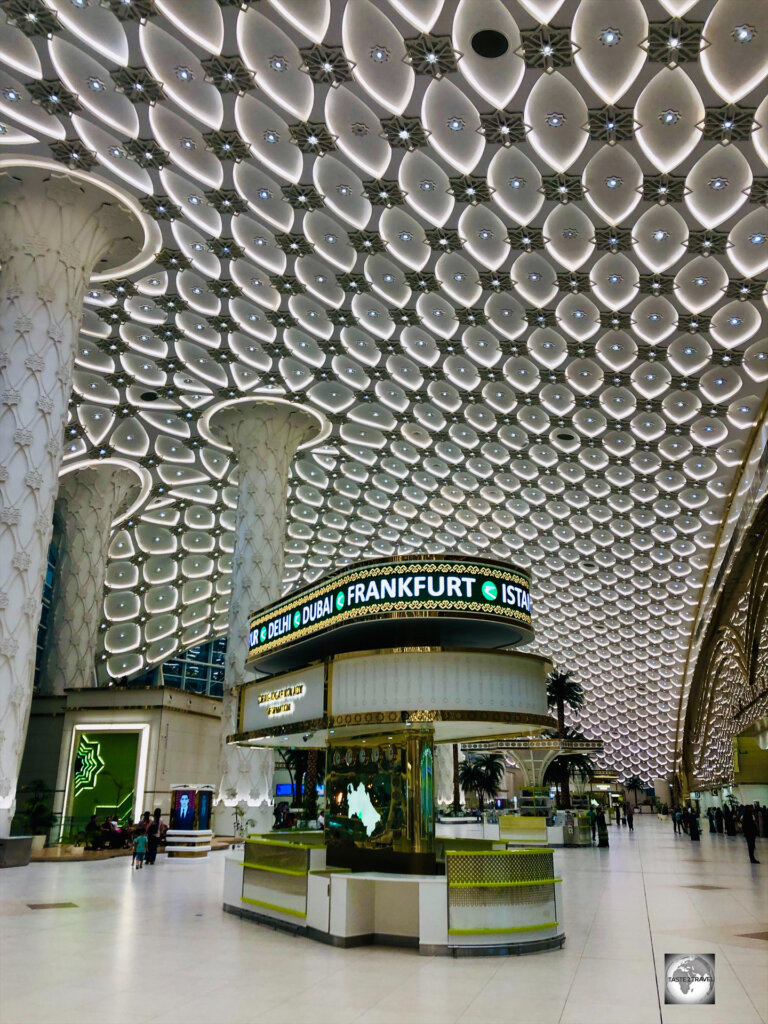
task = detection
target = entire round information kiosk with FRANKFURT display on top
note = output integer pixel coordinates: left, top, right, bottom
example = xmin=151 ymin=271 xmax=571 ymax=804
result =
xmin=224 ymin=556 xmax=565 ymax=954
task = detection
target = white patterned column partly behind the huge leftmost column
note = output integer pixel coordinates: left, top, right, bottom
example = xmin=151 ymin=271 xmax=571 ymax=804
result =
xmin=40 ymin=459 xmax=140 ymax=695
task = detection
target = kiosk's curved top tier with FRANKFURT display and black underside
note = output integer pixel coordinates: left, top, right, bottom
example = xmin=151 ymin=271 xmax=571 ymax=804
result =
xmin=248 ymin=558 xmax=532 ymax=671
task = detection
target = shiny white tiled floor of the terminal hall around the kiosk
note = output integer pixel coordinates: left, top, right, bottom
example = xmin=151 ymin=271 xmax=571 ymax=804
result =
xmin=0 ymin=816 xmax=768 ymax=1024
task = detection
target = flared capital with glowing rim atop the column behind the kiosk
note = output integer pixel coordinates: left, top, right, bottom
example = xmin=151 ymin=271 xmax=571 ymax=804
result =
xmin=199 ymin=395 xmax=331 ymax=455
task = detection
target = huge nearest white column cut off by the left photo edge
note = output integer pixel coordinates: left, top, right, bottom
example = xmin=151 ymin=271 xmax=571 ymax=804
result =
xmin=0 ymin=166 xmax=144 ymax=836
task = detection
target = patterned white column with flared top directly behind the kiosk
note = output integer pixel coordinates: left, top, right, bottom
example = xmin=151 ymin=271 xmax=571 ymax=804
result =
xmin=211 ymin=398 xmax=321 ymax=806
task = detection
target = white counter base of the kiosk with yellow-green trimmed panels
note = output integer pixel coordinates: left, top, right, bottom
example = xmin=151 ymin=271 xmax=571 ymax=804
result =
xmin=223 ymin=837 xmax=565 ymax=955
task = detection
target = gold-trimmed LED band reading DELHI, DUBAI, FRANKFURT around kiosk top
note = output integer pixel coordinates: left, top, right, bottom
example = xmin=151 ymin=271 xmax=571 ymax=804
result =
xmin=248 ymin=558 xmax=531 ymax=660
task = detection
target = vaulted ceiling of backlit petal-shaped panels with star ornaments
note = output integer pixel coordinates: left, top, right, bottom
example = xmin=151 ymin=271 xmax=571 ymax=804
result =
xmin=0 ymin=0 xmax=768 ymax=777
